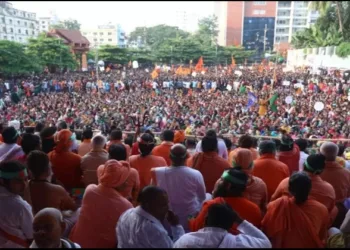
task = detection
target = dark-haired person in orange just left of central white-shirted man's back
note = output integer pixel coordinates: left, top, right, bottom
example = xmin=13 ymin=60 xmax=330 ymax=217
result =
xmin=129 ymin=133 xmax=167 ymax=190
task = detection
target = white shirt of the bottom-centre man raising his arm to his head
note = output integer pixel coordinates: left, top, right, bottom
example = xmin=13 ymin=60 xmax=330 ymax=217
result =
xmin=174 ymin=221 xmax=272 ymax=248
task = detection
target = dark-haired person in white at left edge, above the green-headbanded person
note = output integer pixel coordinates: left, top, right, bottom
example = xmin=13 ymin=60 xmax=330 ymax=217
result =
xmin=0 ymin=127 xmax=24 ymax=162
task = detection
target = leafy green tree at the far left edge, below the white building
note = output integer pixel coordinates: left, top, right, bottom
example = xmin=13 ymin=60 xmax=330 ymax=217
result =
xmin=0 ymin=40 xmax=42 ymax=76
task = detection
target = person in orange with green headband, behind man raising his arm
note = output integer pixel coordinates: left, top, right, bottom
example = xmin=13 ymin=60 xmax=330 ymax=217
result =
xmin=189 ymin=169 xmax=262 ymax=234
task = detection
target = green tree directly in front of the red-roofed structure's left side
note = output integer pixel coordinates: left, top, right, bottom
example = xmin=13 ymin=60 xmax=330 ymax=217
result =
xmin=27 ymin=35 xmax=77 ymax=72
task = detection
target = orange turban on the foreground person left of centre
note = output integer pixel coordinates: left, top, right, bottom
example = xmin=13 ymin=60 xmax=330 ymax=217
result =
xmin=97 ymin=160 xmax=130 ymax=188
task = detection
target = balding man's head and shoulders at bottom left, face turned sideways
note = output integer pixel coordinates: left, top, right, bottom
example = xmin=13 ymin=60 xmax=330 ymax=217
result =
xmin=30 ymin=207 xmax=80 ymax=248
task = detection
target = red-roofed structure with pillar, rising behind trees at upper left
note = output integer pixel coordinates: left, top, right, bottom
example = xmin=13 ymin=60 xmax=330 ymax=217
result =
xmin=47 ymin=29 xmax=90 ymax=71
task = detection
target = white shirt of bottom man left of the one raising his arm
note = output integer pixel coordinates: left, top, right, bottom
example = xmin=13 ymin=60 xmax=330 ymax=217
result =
xmin=116 ymin=206 xmax=185 ymax=248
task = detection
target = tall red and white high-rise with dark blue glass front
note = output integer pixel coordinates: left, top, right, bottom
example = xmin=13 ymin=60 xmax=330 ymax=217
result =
xmin=214 ymin=1 xmax=318 ymax=52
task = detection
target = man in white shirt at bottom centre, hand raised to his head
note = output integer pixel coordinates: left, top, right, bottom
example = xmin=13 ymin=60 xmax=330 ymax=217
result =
xmin=174 ymin=204 xmax=271 ymax=248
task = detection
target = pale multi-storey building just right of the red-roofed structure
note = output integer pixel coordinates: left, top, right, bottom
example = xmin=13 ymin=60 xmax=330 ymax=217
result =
xmin=82 ymin=24 xmax=126 ymax=48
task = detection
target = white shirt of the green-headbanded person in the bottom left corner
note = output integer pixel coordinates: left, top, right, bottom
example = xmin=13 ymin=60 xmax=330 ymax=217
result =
xmin=0 ymin=186 xmax=33 ymax=248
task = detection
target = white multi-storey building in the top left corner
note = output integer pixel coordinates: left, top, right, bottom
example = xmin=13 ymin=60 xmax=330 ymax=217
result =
xmin=0 ymin=1 xmax=39 ymax=43
